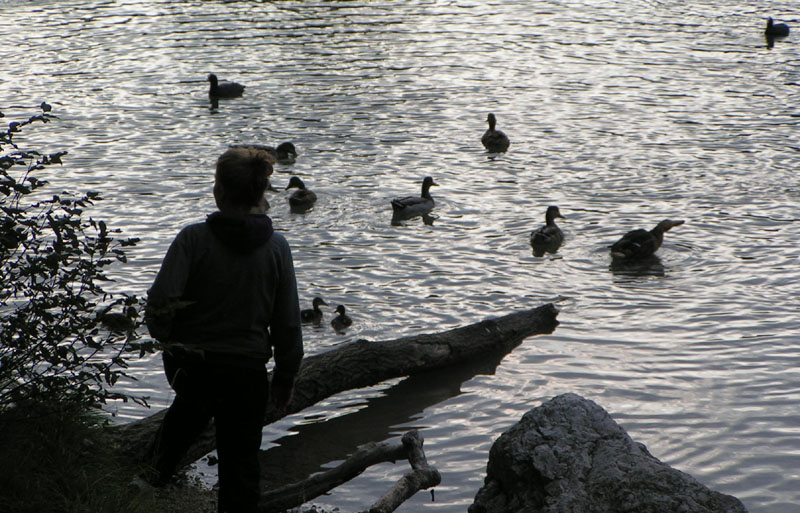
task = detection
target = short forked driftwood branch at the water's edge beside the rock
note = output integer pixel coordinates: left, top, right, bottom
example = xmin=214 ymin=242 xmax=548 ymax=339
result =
xmin=258 ymin=430 xmax=442 ymax=513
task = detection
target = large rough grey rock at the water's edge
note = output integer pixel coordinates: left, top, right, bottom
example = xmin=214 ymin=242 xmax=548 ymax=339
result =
xmin=469 ymin=394 xmax=747 ymax=513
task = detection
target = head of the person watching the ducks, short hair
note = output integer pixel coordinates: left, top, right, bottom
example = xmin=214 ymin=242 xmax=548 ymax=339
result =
xmin=214 ymin=147 xmax=272 ymax=212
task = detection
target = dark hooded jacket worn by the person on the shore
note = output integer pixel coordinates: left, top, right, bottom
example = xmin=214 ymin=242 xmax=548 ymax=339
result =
xmin=146 ymin=212 xmax=303 ymax=375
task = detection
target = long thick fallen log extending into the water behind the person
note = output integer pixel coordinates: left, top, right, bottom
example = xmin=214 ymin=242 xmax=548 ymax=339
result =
xmin=114 ymin=303 xmax=558 ymax=465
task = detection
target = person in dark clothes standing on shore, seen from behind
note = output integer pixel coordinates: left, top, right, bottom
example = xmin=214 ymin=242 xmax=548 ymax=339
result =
xmin=145 ymin=148 xmax=303 ymax=513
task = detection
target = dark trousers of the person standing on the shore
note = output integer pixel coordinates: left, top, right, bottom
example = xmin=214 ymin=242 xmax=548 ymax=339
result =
xmin=153 ymin=353 xmax=269 ymax=513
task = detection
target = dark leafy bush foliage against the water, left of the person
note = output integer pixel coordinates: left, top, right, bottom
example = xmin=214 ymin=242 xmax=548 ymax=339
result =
xmin=0 ymin=103 xmax=155 ymax=413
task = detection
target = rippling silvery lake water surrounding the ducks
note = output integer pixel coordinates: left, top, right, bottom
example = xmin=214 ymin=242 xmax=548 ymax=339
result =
xmin=0 ymin=0 xmax=800 ymax=513
